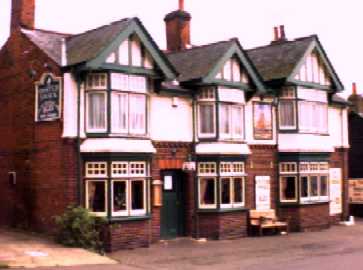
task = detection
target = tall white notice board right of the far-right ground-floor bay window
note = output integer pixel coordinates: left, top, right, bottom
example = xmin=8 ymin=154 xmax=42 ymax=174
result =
xmin=329 ymin=168 xmax=343 ymax=215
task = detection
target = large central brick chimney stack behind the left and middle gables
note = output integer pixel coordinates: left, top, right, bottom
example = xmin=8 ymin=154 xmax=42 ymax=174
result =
xmin=164 ymin=0 xmax=192 ymax=52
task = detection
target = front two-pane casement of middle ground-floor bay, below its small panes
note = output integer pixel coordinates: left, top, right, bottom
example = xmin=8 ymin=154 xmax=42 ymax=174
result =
xmin=220 ymin=177 xmax=245 ymax=208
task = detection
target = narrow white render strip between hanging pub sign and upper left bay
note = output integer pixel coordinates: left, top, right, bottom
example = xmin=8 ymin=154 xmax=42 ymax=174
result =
xmin=62 ymin=73 xmax=77 ymax=138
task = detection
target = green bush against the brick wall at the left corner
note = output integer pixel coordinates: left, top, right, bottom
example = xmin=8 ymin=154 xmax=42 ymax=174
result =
xmin=55 ymin=206 xmax=106 ymax=253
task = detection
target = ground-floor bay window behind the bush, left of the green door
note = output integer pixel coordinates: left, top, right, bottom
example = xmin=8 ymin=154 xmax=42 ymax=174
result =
xmin=85 ymin=161 xmax=149 ymax=217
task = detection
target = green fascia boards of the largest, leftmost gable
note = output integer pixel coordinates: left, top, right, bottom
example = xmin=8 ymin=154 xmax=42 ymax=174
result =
xmin=86 ymin=18 xmax=177 ymax=81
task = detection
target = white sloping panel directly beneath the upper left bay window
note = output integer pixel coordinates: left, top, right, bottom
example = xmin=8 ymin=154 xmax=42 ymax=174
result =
xmin=81 ymin=138 xmax=156 ymax=153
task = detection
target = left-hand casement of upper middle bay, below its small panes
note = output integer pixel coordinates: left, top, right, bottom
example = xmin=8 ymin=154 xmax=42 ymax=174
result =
xmin=198 ymin=102 xmax=216 ymax=138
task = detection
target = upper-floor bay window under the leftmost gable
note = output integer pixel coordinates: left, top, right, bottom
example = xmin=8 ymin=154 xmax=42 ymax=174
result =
xmin=86 ymin=73 xmax=147 ymax=135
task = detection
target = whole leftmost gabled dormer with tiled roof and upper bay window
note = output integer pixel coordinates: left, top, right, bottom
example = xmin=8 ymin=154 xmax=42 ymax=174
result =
xmin=65 ymin=18 xmax=176 ymax=137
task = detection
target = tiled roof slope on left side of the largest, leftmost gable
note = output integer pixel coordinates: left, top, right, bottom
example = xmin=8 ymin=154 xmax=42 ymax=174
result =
xmin=67 ymin=18 xmax=133 ymax=65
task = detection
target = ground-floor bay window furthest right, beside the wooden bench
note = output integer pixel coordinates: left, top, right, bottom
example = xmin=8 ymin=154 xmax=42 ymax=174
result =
xmin=280 ymin=162 xmax=329 ymax=203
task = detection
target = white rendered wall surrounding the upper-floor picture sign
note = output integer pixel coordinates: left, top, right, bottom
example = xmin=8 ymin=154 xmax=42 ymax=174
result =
xmin=245 ymin=99 xmax=277 ymax=145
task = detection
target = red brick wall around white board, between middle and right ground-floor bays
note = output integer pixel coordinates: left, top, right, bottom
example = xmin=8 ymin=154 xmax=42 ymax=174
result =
xmin=246 ymin=145 xmax=278 ymax=209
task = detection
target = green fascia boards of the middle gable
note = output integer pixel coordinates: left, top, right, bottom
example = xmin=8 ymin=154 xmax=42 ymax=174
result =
xmin=203 ymin=41 xmax=266 ymax=93
